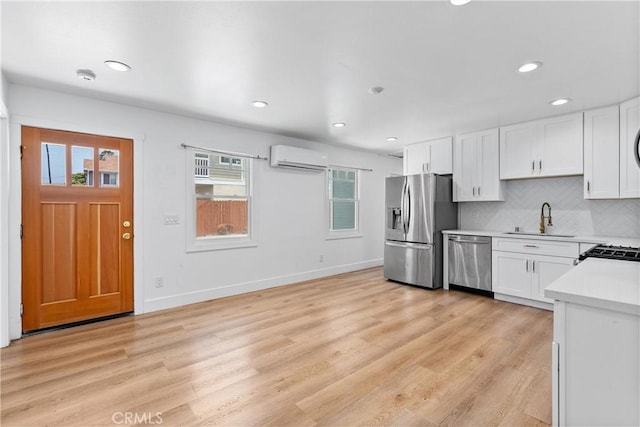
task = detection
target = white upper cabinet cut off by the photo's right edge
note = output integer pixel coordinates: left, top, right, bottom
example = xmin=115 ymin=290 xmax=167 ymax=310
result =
xmin=620 ymin=98 xmax=640 ymax=199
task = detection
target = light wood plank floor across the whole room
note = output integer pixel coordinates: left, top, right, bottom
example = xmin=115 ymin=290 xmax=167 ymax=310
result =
xmin=1 ymin=268 xmax=552 ymax=426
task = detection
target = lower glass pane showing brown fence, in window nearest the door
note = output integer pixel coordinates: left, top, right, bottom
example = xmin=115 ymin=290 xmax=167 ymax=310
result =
xmin=196 ymin=196 xmax=249 ymax=239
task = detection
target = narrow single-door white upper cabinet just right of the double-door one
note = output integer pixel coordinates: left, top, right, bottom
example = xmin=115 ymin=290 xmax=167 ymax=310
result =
xmin=584 ymin=105 xmax=620 ymax=199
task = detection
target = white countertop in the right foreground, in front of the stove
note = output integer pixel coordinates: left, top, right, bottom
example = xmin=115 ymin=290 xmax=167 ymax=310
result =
xmin=544 ymin=258 xmax=640 ymax=315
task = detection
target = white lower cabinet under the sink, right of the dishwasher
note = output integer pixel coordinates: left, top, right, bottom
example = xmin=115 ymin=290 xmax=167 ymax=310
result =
xmin=491 ymin=238 xmax=579 ymax=309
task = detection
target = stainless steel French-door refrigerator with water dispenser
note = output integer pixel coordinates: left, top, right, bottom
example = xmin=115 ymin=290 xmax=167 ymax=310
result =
xmin=384 ymin=174 xmax=458 ymax=289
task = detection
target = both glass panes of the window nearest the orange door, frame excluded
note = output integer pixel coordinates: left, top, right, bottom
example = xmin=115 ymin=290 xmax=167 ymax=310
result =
xmin=193 ymin=153 xmax=250 ymax=239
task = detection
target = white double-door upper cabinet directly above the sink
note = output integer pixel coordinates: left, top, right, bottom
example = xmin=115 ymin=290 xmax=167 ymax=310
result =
xmin=500 ymin=113 xmax=583 ymax=179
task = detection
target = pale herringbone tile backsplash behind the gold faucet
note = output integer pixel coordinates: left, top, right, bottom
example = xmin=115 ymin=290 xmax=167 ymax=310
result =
xmin=458 ymin=176 xmax=640 ymax=238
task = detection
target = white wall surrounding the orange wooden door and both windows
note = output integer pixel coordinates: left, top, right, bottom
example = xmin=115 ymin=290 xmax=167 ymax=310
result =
xmin=9 ymin=85 xmax=402 ymax=344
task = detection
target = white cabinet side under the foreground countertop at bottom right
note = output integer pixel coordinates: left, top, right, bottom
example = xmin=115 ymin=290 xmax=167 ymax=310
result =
xmin=552 ymin=302 xmax=640 ymax=426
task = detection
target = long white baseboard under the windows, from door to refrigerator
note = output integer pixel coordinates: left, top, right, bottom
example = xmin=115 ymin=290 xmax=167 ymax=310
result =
xmin=140 ymin=258 xmax=383 ymax=314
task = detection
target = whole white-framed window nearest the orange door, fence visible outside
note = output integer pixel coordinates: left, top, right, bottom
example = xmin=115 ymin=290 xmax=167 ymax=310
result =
xmin=187 ymin=150 xmax=253 ymax=250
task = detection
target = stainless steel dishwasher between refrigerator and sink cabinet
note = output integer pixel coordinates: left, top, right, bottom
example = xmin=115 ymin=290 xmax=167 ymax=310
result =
xmin=449 ymin=234 xmax=491 ymax=291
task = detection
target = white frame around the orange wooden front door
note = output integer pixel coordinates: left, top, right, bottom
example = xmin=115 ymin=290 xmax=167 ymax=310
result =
xmin=0 ymin=116 xmax=144 ymax=346
